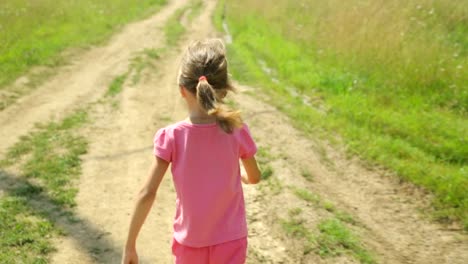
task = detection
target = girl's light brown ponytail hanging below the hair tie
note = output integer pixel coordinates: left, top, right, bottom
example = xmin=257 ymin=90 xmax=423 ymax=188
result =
xmin=196 ymin=76 xmax=242 ymax=134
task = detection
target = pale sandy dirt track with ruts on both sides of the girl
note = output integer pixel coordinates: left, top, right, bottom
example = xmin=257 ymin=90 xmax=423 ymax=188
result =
xmin=0 ymin=0 xmax=468 ymax=264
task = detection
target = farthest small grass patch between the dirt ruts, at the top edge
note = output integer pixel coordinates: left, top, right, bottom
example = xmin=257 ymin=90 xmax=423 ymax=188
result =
xmin=164 ymin=0 xmax=203 ymax=47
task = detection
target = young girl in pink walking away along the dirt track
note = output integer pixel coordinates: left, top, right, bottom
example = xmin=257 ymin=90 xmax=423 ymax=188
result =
xmin=123 ymin=39 xmax=260 ymax=264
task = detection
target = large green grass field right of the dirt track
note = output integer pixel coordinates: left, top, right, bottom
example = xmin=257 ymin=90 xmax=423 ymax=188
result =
xmin=218 ymin=0 xmax=468 ymax=230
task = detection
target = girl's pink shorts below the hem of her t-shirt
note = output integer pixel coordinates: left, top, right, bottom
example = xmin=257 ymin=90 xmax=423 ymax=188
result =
xmin=172 ymin=237 xmax=247 ymax=264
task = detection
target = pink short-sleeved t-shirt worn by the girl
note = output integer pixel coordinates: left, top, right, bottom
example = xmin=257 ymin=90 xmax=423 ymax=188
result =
xmin=154 ymin=121 xmax=257 ymax=247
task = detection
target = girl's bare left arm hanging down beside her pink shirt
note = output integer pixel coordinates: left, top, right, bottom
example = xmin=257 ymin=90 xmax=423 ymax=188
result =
xmin=124 ymin=157 xmax=169 ymax=263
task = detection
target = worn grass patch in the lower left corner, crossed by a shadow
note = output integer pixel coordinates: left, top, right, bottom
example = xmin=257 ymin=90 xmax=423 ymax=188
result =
xmin=0 ymin=110 xmax=88 ymax=263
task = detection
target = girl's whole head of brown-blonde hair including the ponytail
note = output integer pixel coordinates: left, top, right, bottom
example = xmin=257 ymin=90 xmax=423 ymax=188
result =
xmin=178 ymin=39 xmax=242 ymax=133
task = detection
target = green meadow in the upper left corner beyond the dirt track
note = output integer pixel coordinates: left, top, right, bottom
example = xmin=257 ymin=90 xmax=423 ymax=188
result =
xmin=0 ymin=0 xmax=166 ymax=87
